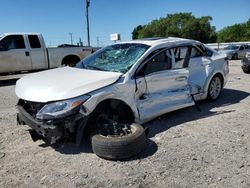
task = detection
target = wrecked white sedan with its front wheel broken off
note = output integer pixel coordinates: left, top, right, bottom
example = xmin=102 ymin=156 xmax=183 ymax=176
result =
xmin=16 ymin=37 xmax=229 ymax=159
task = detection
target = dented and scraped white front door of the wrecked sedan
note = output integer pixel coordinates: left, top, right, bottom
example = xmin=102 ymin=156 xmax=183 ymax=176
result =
xmin=135 ymin=47 xmax=193 ymax=122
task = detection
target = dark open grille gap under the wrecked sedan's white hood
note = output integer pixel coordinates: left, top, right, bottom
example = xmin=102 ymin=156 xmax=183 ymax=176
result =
xmin=17 ymin=99 xmax=45 ymax=118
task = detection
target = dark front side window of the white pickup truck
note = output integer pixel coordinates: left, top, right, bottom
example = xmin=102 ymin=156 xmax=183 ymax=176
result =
xmin=2 ymin=35 xmax=25 ymax=50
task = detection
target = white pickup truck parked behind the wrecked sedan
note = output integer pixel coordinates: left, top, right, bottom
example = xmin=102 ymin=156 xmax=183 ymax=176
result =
xmin=0 ymin=33 xmax=95 ymax=74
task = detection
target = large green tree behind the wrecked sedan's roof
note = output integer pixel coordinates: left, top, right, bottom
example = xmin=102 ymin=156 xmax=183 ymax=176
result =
xmin=132 ymin=13 xmax=217 ymax=43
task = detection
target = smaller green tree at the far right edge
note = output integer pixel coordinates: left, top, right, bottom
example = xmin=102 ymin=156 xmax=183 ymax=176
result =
xmin=217 ymin=19 xmax=250 ymax=42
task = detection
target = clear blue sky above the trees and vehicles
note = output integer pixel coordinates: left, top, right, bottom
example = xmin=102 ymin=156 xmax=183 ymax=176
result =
xmin=0 ymin=0 xmax=250 ymax=46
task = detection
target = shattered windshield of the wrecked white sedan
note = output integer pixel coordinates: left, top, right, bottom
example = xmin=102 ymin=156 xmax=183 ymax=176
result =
xmin=76 ymin=43 xmax=149 ymax=73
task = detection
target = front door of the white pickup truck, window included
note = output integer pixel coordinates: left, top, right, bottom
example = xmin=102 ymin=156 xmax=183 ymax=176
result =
xmin=0 ymin=35 xmax=32 ymax=72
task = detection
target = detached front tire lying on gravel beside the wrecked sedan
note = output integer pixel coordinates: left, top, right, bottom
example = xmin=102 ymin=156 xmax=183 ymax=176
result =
xmin=91 ymin=123 xmax=147 ymax=160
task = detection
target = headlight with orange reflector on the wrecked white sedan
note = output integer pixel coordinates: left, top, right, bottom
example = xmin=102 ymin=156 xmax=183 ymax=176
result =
xmin=36 ymin=95 xmax=90 ymax=119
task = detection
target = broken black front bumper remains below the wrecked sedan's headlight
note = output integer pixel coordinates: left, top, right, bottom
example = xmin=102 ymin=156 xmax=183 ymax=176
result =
xmin=17 ymin=102 xmax=87 ymax=145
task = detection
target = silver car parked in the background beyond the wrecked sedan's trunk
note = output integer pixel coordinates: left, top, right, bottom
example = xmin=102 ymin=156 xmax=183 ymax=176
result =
xmin=220 ymin=45 xmax=250 ymax=60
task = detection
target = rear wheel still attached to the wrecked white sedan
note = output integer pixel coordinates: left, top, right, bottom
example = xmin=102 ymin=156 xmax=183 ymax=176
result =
xmin=207 ymin=75 xmax=222 ymax=101
